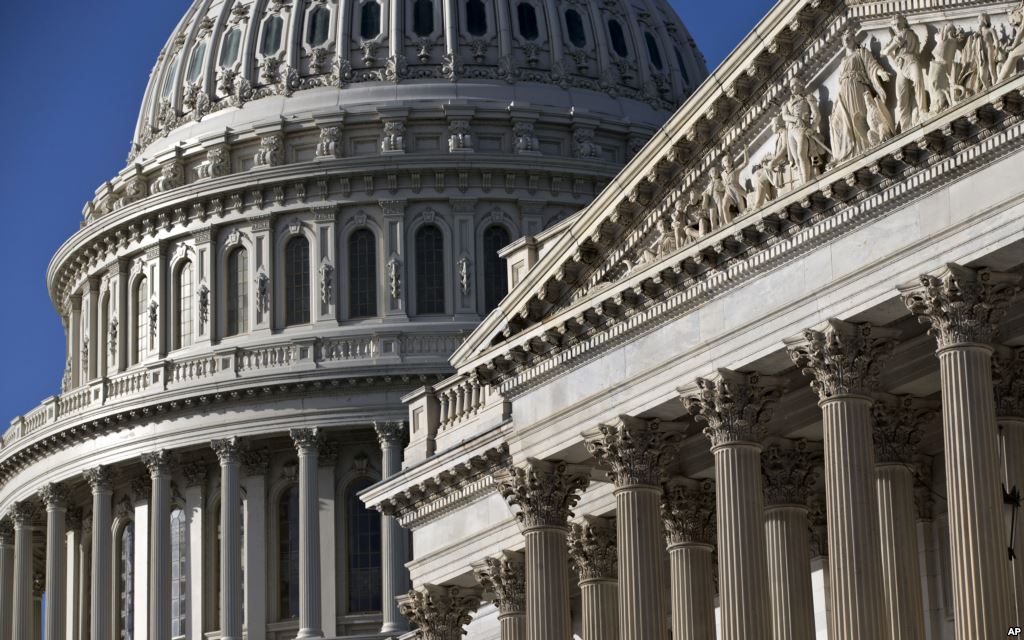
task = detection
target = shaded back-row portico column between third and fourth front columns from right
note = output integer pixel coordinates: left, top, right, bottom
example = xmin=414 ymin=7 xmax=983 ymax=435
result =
xmin=659 ymin=478 xmax=715 ymax=640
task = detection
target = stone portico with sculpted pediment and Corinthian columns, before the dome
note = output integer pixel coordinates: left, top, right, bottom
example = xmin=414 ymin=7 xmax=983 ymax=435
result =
xmin=361 ymin=0 xmax=1024 ymax=640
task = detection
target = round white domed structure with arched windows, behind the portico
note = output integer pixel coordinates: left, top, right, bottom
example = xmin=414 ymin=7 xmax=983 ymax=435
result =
xmin=0 ymin=0 xmax=707 ymax=640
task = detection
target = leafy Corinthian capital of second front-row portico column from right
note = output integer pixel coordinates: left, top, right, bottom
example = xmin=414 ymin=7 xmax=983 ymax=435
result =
xmin=785 ymin=318 xmax=899 ymax=401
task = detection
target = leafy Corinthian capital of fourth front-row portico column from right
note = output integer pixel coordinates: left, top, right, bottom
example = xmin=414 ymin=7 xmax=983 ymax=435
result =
xmin=583 ymin=416 xmax=683 ymax=487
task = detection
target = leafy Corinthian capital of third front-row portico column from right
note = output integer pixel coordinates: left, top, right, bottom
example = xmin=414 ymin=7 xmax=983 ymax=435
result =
xmin=683 ymin=369 xmax=781 ymax=450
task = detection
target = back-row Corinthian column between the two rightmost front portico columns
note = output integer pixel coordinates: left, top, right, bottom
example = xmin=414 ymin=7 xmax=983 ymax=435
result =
xmin=872 ymin=395 xmax=935 ymax=640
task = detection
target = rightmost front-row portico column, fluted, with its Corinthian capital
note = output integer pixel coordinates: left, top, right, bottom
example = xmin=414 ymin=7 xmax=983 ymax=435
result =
xmin=903 ymin=264 xmax=1020 ymax=638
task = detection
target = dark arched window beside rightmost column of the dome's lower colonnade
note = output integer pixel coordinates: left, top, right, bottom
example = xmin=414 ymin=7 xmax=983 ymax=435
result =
xmin=345 ymin=478 xmax=381 ymax=613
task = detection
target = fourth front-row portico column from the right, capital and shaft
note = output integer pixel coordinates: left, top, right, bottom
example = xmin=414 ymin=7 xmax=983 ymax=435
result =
xmin=584 ymin=416 xmax=681 ymax=640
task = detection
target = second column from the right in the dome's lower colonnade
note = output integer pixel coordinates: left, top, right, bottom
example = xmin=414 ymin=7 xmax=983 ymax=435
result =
xmin=289 ymin=428 xmax=324 ymax=639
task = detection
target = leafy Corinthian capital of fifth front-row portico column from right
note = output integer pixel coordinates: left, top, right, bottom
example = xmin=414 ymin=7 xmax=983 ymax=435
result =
xmin=493 ymin=459 xmax=590 ymax=530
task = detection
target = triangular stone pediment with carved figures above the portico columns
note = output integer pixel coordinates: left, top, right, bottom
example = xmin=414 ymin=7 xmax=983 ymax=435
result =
xmin=453 ymin=0 xmax=1024 ymax=374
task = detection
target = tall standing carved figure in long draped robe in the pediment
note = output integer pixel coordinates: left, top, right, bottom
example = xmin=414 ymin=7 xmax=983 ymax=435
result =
xmin=828 ymin=31 xmax=892 ymax=162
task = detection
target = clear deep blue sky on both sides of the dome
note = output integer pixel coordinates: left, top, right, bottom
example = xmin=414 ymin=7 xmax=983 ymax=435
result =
xmin=0 ymin=0 xmax=773 ymax=423
